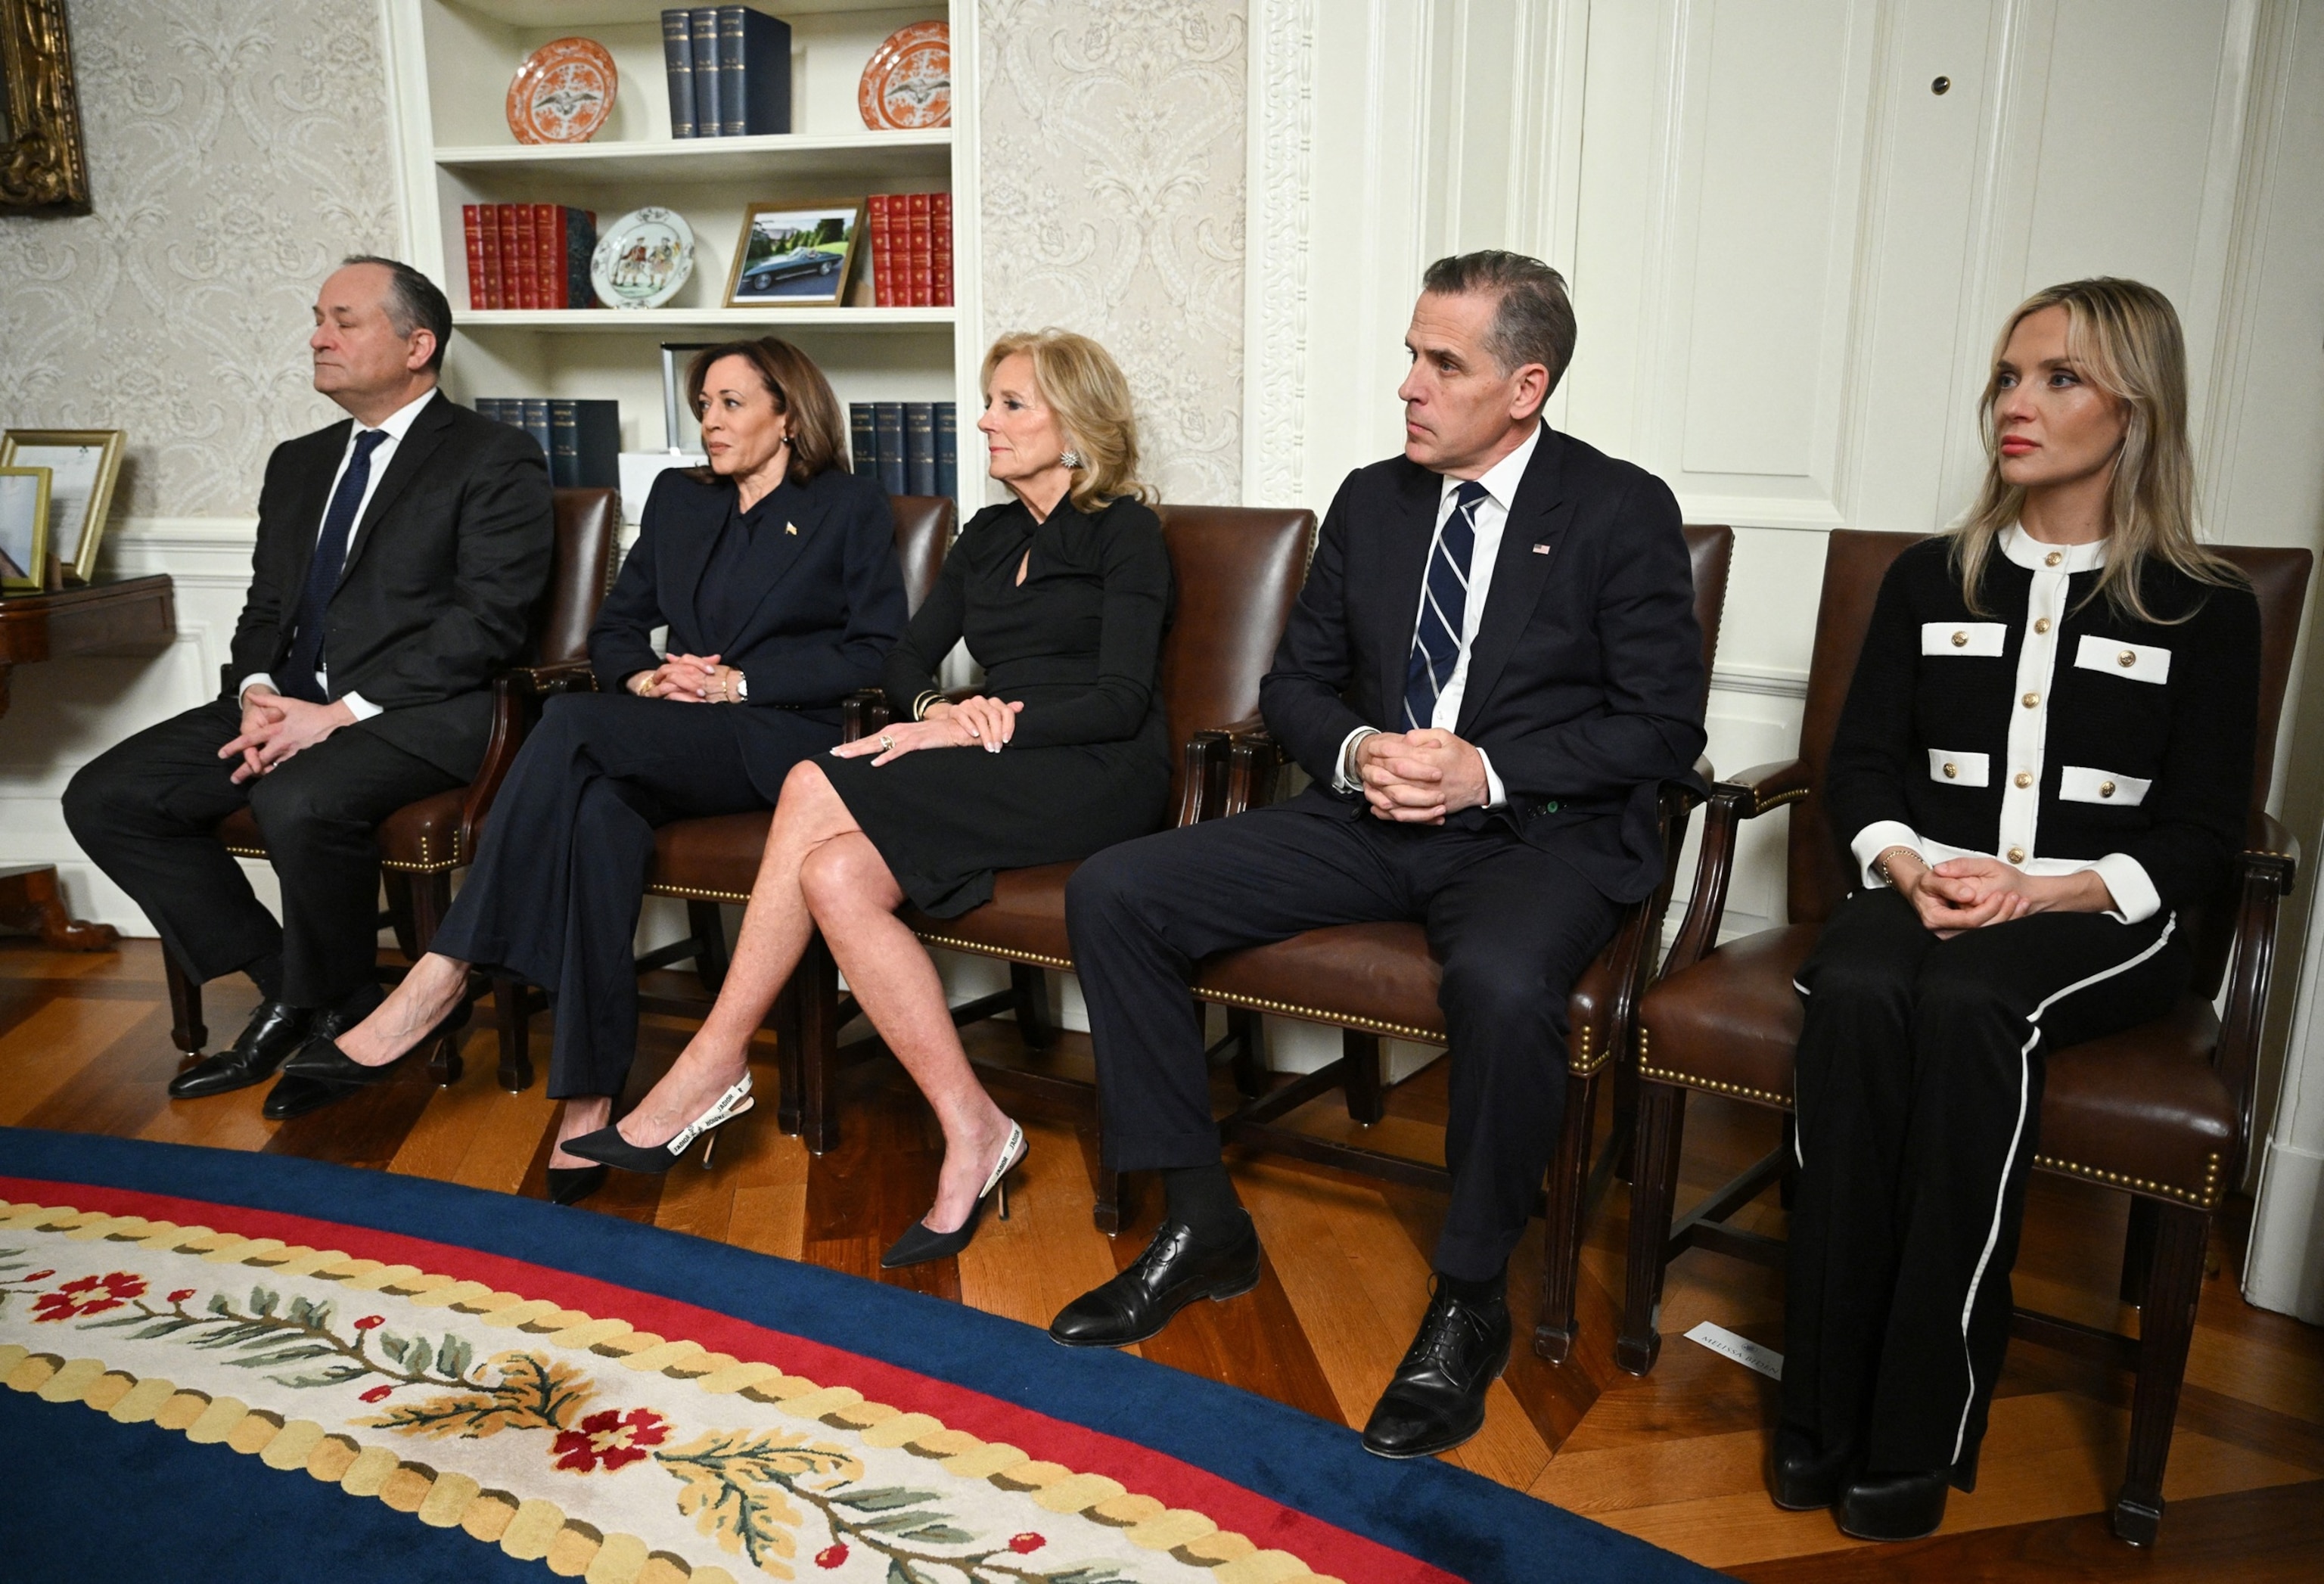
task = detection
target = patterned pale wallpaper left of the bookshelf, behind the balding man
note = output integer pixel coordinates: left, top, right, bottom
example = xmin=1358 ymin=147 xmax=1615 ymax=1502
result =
xmin=0 ymin=0 xmax=397 ymax=518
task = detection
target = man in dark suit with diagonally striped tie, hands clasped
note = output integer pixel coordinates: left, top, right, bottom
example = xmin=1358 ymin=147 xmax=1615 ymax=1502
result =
xmin=1051 ymin=253 xmax=1704 ymax=1456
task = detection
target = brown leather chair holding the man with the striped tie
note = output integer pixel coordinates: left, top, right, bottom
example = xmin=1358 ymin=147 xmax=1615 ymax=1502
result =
xmin=1195 ymin=525 xmax=1734 ymax=1363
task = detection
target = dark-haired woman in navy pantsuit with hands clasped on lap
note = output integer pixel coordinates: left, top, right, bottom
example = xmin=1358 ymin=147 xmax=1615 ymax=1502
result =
xmin=284 ymin=337 xmax=904 ymax=1203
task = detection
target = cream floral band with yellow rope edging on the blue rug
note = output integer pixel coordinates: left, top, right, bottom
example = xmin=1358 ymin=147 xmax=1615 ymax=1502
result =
xmin=0 ymin=1203 xmax=1322 ymax=1584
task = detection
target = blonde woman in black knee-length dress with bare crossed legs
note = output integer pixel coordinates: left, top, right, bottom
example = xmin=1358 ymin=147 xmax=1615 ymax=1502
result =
xmin=570 ymin=330 xmax=1171 ymax=1266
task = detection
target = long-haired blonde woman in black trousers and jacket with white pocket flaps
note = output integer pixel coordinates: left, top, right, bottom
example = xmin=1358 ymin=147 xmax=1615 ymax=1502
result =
xmin=1773 ymin=278 xmax=2259 ymax=1540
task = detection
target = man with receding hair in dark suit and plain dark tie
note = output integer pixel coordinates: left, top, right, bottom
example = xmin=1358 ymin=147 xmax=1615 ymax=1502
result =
xmin=65 ymin=258 xmax=553 ymax=1115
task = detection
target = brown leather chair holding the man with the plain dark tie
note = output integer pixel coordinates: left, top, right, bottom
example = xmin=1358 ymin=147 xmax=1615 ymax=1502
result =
xmin=163 ymin=490 xmax=620 ymax=1085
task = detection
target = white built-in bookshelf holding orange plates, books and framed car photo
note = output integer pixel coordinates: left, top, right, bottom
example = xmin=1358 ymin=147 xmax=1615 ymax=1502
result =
xmin=386 ymin=0 xmax=983 ymax=499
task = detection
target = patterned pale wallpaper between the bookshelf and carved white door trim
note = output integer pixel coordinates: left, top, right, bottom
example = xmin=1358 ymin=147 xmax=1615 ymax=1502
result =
xmin=978 ymin=0 xmax=1246 ymax=502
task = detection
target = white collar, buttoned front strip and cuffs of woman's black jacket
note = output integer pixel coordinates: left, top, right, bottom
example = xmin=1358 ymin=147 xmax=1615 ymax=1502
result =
xmin=1847 ymin=525 xmax=2164 ymax=924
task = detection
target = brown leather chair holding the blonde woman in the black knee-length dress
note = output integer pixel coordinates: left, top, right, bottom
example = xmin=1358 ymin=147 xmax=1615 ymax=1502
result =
xmin=785 ymin=506 xmax=1316 ymax=1198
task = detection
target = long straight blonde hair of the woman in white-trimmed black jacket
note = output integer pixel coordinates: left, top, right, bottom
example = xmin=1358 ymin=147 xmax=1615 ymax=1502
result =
xmin=1952 ymin=276 xmax=2245 ymax=623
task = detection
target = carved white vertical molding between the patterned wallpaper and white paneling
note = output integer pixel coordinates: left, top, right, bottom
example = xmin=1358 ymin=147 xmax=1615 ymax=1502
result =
xmin=1244 ymin=0 xmax=1316 ymax=506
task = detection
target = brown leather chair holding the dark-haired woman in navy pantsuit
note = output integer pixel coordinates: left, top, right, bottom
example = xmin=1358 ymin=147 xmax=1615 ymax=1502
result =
xmin=492 ymin=495 xmax=960 ymax=1096
